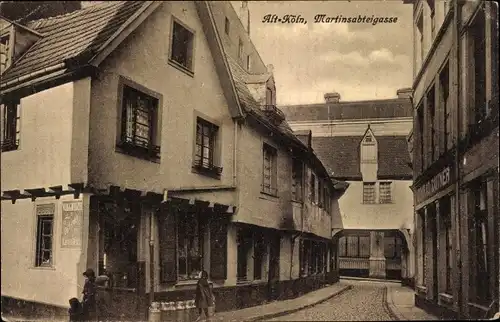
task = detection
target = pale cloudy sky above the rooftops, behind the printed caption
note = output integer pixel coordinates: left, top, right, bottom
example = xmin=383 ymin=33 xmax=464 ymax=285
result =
xmin=231 ymin=0 xmax=413 ymax=105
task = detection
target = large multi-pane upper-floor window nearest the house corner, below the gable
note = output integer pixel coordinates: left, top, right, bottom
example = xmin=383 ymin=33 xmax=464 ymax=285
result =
xmin=121 ymin=85 xmax=160 ymax=157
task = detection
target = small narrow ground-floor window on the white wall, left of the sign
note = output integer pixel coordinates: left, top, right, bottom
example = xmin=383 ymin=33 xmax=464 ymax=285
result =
xmin=35 ymin=204 xmax=55 ymax=267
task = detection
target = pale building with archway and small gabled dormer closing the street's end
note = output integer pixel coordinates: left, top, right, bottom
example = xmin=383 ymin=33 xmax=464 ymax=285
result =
xmin=281 ymin=89 xmax=414 ymax=285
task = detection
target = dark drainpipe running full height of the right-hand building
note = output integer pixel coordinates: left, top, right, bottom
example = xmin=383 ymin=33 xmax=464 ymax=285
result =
xmin=453 ymin=0 xmax=463 ymax=319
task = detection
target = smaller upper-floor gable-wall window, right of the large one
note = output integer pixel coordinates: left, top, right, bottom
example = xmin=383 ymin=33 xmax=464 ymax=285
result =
xmin=194 ymin=117 xmax=222 ymax=176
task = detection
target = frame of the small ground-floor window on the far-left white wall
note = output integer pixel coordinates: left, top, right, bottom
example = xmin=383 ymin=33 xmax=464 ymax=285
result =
xmin=32 ymin=203 xmax=57 ymax=269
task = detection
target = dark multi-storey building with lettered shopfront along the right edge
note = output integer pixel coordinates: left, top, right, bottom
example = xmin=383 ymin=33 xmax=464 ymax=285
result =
xmin=411 ymin=1 xmax=499 ymax=319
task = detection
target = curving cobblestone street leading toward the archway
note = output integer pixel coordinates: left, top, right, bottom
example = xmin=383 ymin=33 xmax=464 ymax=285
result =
xmin=268 ymin=281 xmax=400 ymax=321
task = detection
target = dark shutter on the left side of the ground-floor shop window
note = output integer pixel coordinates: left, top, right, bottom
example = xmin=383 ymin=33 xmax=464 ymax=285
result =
xmin=159 ymin=210 xmax=177 ymax=283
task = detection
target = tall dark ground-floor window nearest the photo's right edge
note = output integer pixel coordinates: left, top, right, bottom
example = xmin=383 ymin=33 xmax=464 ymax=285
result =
xmin=470 ymin=182 xmax=491 ymax=304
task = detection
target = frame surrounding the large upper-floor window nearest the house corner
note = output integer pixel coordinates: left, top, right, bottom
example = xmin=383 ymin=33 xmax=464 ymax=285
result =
xmin=115 ymin=76 xmax=163 ymax=163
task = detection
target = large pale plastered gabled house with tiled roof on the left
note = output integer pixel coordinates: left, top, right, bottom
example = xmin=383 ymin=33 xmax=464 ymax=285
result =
xmin=1 ymin=1 xmax=346 ymax=318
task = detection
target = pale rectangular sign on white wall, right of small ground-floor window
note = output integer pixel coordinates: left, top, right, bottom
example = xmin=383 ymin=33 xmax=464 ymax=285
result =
xmin=61 ymin=200 xmax=83 ymax=248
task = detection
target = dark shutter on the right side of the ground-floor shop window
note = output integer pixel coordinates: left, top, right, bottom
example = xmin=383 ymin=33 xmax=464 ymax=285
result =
xmin=210 ymin=217 xmax=229 ymax=280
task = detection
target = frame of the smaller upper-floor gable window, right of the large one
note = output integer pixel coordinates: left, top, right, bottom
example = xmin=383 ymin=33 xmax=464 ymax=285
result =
xmin=192 ymin=111 xmax=223 ymax=179
